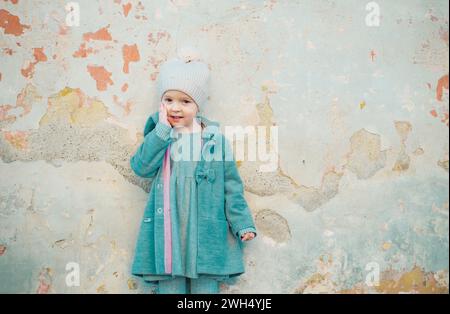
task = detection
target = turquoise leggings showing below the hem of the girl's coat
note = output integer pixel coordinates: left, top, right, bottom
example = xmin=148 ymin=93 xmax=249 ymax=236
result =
xmin=157 ymin=277 xmax=220 ymax=294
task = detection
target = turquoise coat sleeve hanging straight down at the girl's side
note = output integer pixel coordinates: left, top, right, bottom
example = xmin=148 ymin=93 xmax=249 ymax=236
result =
xmin=222 ymin=137 xmax=256 ymax=239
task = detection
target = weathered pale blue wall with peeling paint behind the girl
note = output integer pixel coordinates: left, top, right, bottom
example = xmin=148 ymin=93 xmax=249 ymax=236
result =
xmin=0 ymin=0 xmax=449 ymax=293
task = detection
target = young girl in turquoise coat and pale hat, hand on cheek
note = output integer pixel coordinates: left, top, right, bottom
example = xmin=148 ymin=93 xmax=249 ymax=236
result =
xmin=130 ymin=59 xmax=256 ymax=294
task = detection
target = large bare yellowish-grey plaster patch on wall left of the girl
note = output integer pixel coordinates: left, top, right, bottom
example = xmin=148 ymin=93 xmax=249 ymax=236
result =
xmin=0 ymin=88 xmax=151 ymax=191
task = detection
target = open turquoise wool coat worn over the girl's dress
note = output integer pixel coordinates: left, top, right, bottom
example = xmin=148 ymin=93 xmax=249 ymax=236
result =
xmin=130 ymin=112 xmax=256 ymax=277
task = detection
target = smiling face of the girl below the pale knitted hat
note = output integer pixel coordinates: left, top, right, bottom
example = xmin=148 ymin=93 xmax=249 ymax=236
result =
xmin=162 ymin=90 xmax=198 ymax=130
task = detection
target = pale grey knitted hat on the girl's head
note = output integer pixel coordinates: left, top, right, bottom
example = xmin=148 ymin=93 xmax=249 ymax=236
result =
xmin=157 ymin=55 xmax=209 ymax=110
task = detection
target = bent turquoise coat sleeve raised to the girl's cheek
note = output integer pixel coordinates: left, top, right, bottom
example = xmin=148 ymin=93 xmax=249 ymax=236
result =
xmin=130 ymin=122 xmax=172 ymax=178
